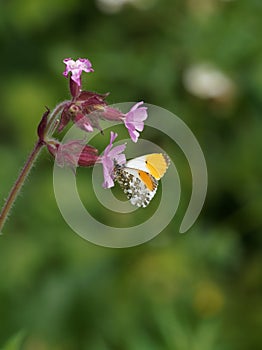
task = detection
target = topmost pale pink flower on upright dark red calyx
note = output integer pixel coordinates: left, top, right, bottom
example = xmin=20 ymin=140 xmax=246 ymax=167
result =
xmin=63 ymin=58 xmax=94 ymax=87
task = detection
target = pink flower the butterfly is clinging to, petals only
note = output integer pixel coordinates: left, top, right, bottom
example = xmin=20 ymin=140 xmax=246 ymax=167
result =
xmin=100 ymin=131 xmax=126 ymax=188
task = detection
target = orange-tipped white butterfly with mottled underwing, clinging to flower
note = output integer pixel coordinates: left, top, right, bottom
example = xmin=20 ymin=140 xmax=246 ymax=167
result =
xmin=114 ymin=153 xmax=170 ymax=208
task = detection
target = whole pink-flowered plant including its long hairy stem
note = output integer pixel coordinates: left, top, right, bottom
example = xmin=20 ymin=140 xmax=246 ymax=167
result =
xmin=0 ymin=58 xmax=150 ymax=233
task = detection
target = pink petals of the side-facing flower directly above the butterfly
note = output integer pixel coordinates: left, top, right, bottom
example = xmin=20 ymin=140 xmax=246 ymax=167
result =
xmin=124 ymin=101 xmax=147 ymax=142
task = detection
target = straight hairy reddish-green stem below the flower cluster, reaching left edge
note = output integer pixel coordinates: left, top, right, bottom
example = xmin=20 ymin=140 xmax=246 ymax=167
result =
xmin=0 ymin=141 xmax=43 ymax=234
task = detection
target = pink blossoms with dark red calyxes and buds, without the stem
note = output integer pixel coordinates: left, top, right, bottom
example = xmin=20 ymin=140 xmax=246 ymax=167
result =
xmin=44 ymin=58 xmax=147 ymax=188
